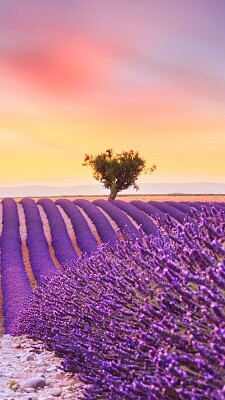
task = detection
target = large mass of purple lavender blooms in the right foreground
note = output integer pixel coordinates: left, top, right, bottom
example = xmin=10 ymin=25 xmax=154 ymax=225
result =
xmin=14 ymin=207 xmax=225 ymax=400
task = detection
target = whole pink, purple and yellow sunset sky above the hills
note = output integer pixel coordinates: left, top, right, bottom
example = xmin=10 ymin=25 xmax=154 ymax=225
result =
xmin=0 ymin=0 xmax=225 ymax=194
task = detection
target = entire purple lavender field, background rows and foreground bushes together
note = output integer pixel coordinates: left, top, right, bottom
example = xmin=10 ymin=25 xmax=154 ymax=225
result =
xmin=0 ymin=198 xmax=225 ymax=400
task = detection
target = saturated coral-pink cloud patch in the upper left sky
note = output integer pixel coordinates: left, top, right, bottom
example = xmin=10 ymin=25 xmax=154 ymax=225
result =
xmin=2 ymin=36 xmax=110 ymax=95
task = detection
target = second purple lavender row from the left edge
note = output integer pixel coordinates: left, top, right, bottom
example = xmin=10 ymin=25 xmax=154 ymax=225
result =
xmin=21 ymin=198 xmax=57 ymax=283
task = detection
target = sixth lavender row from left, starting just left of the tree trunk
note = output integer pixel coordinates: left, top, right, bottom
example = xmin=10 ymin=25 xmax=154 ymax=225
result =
xmin=93 ymin=199 xmax=141 ymax=238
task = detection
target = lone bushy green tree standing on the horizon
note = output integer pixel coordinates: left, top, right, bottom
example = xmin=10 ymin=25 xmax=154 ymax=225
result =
xmin=83 ymin=149 xmax=156 ymax=201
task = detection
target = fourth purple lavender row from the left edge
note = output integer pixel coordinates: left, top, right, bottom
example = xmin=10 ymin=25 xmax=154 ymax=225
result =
xmin=55 ymin=199 xmax=98 ymax=254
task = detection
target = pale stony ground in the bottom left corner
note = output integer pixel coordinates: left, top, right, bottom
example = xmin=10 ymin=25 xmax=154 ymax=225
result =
xmin=0 ymin=335 xmax=85 ymax=400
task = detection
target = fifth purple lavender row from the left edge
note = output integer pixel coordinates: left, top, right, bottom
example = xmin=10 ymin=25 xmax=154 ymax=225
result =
xmin=74 ymin=199 xmax=118 ymax=245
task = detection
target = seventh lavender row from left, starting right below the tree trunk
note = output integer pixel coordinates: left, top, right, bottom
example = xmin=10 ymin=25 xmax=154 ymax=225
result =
xmin=113 ymin=200 xmax=158 ymax=235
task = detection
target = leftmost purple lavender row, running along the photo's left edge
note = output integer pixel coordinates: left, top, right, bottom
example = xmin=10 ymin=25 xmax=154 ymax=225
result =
xmin=1 ymin=198 xmax=32 ymax=333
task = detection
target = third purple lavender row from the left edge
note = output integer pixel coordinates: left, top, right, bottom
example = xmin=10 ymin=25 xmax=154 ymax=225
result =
xmin=38 ymin=198 xmax=78 ymax=264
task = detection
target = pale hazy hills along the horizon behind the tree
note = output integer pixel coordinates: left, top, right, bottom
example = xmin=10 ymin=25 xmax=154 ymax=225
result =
xmin=0 ymin=182 xmax=225 ymax=197
